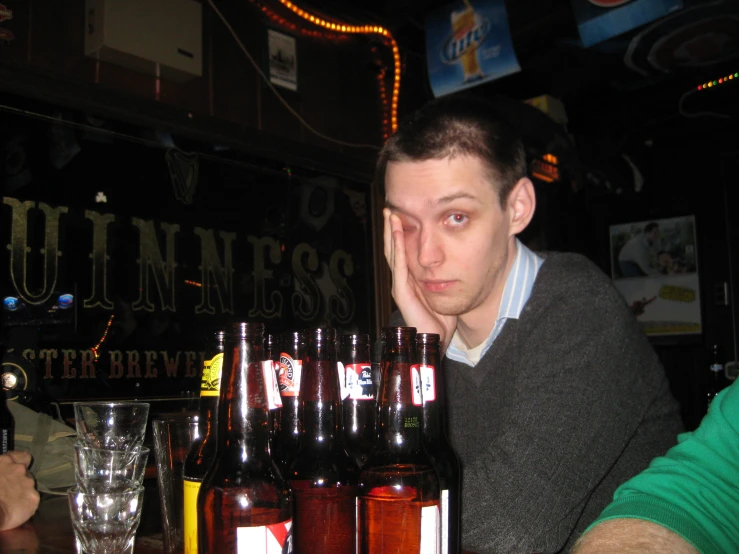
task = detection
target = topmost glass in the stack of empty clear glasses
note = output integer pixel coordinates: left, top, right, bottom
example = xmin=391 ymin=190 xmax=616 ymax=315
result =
xmin=74 ymin=402 xmax=149 ymax=450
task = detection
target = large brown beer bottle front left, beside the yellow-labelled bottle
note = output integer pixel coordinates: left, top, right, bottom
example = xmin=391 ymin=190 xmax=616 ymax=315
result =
xmin=198 ymin=323 xmax=293 ymax=554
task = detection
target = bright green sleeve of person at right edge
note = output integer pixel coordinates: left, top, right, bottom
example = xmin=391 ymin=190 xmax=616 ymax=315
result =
xmin=588 ymin=382 xmax=739 ymax=554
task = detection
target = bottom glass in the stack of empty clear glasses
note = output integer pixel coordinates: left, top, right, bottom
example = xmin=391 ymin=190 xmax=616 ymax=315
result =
xmin=67 ymin=487 xmax=144 ymax=554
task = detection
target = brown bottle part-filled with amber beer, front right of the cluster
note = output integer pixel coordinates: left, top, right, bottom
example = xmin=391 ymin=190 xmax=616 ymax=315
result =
xmin=359 ymin=327 xmax=439 ymax=554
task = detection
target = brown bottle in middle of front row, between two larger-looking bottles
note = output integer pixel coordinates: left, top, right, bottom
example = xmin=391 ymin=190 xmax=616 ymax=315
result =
xmin=289 ymin=329 xmax=359 ymax=554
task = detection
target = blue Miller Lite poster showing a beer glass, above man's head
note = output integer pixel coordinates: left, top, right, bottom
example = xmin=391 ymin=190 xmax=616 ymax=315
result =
xmin=426 ymin=0 xmax=521 ymax=98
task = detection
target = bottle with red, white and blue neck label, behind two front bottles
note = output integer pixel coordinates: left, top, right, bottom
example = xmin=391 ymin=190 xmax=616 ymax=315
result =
xmin=340 ymin=334 xmax=375 ymax=467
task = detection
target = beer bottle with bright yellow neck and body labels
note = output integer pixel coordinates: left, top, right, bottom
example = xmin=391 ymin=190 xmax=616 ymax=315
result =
xmin=182 ymin=331 xmax=226 ymax=554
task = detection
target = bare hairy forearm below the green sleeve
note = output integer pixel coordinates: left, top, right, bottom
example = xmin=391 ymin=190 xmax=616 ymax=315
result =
xmin=570 ymin=519 xmax=698 ymax=554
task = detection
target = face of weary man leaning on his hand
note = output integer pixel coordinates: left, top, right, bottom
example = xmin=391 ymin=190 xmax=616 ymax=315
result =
xmin=385 ymin=157 xmax=512 ymax=318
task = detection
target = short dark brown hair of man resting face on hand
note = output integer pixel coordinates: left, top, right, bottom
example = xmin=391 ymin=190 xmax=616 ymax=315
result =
xmin=375 ymin=94 xmax=526 ymax=206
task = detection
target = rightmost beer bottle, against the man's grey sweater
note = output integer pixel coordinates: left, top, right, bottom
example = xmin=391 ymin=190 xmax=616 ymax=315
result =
xmin=416 ymin=333 xmax=461 ymax=554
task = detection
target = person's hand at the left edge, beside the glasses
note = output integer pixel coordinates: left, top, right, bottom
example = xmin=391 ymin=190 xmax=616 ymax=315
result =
xmin=0 ymin=451 xmax=40 ymax=531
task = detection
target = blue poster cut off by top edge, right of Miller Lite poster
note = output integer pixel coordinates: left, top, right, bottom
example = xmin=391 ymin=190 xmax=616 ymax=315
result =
xmin=570 ymin=0 xmax=683 ymax=48
